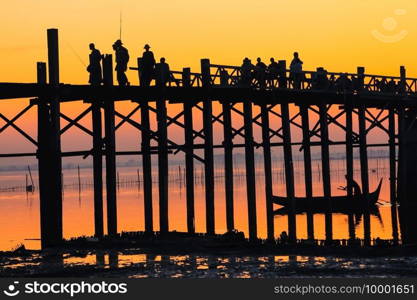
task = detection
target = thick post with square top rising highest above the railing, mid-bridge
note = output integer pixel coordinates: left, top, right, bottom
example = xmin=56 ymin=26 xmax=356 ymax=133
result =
xmin=201 ymin=59 xmax=215 ymax=234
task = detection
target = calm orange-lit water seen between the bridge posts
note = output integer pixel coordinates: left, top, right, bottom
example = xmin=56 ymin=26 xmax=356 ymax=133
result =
xmin=0 ymin=158 xmax=392 ymax=250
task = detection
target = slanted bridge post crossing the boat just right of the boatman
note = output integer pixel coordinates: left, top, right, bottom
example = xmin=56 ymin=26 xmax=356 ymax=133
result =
xmin=358 ymin=104 xmax=371 ymax=246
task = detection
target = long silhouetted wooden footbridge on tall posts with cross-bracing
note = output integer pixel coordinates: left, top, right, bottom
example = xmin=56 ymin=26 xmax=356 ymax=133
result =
xmin=0 ymin=29 xmax=417 ymax=248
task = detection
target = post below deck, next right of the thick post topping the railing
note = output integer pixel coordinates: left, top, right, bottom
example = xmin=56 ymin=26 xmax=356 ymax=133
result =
xmin=222 ymin=100 xmax=235 ymax=232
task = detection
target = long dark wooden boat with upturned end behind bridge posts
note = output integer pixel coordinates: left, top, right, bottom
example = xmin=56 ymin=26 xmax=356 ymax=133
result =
xmin=272 ymin=179 xmax=382 ymax=214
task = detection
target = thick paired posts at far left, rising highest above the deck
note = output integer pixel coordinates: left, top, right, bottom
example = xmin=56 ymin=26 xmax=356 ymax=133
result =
xmin=38 ymin=29 xmax=62 ymax=248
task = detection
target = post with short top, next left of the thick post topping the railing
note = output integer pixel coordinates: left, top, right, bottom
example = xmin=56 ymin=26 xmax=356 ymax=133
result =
xmin=182 ymin=68 xmax=195 ymax=233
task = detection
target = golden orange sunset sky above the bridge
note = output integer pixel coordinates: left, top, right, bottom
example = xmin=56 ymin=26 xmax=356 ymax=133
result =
xmin=0 ymin=0 xmax=417 ymax=152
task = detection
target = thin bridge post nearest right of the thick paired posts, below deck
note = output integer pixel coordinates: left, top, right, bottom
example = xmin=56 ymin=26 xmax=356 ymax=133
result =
xmin=91 ymin=99 xmax=104 ymax=238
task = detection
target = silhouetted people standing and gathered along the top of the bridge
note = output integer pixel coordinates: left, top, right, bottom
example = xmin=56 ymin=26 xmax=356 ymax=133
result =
xmin=87 ymin=40 xmax=405 ymax=94
